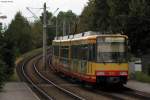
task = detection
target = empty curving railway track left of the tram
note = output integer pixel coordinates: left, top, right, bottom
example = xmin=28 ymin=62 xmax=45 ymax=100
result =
xmin=16 ymin=52 xmax=85 ymax=100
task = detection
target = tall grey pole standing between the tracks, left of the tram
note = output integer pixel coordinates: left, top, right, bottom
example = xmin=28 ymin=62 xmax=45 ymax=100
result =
xmin=43 ymin=3 xmax=47 ymax=71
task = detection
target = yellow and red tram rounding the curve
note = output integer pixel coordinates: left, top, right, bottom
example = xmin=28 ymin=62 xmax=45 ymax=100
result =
xmin=52 ymin=31 xmax=129 ymax=84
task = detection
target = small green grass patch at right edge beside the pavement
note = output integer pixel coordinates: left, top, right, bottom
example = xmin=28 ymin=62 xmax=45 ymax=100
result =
xmin=135 ymin=72 xmax=150 ymax=83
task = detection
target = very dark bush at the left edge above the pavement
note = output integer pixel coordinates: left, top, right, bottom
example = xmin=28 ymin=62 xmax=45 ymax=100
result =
xmin=0 ymin=26 xmax=15 ymax=88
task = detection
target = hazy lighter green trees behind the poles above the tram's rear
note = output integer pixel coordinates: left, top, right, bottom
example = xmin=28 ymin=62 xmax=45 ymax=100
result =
xmin=40 ymin=10 xmax=77 ymax=44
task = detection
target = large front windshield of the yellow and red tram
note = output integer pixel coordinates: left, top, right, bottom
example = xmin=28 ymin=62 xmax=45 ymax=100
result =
xmin=97 ymin=37 xmax=126 ymax=62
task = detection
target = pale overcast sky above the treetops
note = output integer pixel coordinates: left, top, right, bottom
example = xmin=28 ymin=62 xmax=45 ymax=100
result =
xmin=0 ymin=0 xmax=88 ymax=24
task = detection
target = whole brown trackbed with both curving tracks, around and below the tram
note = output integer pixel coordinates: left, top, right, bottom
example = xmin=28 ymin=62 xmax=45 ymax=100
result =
xmin=16 ymin=50 xmax=150 ymax=100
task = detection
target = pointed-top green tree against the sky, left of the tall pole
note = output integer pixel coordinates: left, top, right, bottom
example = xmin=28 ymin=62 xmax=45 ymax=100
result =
xmin=6 ymin=12 xmax=32 ymax=54
